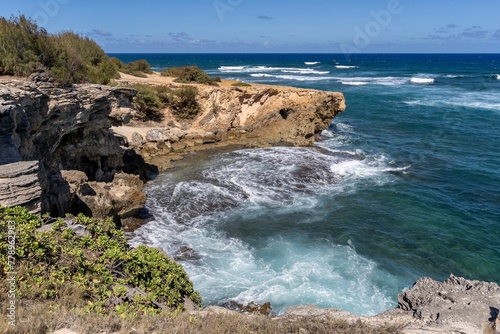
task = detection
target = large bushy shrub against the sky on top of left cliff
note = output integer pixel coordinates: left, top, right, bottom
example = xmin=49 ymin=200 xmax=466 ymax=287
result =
xmin=0 ymin=15 xmax=118 ymax=84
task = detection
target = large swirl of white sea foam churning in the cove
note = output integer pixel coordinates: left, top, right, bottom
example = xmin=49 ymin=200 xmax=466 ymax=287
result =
xmin=131 ymin=145 xmax=408 ymax=315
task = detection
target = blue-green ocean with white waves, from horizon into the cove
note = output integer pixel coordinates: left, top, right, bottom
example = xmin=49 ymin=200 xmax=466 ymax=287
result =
xmin=113 ymin=54 xmax=500 ymax=315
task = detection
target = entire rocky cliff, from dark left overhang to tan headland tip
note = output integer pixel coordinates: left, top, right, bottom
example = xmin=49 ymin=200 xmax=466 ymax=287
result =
xmin=0 ymin=78 xmax=345 ymax=223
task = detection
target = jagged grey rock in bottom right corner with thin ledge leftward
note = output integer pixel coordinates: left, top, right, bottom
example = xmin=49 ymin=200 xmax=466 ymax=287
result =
xmin=286 ymin=275 xmax=500 ymax=334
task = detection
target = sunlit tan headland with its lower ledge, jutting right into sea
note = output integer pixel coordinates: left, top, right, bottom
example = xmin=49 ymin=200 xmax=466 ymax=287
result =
xmin=113 ymin=83 xmax=345 ymax=168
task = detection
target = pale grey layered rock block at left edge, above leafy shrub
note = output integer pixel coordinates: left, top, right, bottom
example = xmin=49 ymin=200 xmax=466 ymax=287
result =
xmin=0 ymin=161 xmax=42 ymax=213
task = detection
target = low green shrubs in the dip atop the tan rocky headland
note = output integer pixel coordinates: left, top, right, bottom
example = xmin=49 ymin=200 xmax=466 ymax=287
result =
xmin=130 ymin=84 xmax=200 ymax=120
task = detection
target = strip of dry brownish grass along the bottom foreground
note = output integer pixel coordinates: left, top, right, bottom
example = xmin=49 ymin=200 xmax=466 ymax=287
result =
xmin=0 ymin=295 xmax=403 ymax=334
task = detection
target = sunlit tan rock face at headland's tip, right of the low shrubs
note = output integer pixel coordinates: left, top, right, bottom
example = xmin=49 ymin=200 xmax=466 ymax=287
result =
xmin=192 ymin=85 xmax=345 ymax=145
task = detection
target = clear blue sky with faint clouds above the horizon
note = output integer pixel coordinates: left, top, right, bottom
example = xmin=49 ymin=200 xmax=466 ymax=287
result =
xmin=0 ymin=0 xmax=500 ymax=53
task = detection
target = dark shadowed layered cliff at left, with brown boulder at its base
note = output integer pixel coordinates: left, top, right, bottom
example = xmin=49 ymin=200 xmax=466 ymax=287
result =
xmin=0 ymin=79 xmax=153 ymax=222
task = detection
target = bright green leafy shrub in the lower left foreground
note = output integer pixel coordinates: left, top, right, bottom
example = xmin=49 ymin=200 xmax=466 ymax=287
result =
xmin=0 ymin=207 xmax=201 ymax=316
